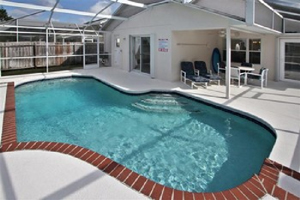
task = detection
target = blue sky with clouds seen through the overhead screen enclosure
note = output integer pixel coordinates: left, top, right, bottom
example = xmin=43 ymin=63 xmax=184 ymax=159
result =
xmin=3 ymin=0 xmax=120 ymax=24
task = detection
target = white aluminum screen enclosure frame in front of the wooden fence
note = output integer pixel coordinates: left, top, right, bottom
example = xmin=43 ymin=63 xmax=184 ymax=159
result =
xmin=0 ymin=0 xmax=147 ymax=77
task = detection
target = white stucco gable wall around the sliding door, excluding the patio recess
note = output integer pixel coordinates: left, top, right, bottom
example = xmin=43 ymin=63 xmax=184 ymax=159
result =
xmin=112 ymin=3 xmax=238 ymax=81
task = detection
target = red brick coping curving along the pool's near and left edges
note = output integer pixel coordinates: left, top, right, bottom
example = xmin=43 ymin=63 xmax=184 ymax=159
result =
xmin=0 ymin=83 xmax=300 ymax=200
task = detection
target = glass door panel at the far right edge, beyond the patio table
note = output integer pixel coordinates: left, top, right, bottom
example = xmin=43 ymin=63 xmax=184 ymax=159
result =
xmin=284 ymin=42 xmax=300 ymax=81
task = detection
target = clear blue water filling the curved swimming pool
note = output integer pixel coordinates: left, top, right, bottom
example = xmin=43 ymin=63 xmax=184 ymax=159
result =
xmin=16 ymin=78 xmax=275 ymax=192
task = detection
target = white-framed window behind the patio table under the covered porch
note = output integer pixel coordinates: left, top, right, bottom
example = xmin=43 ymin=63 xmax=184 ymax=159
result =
xmin=223 ymin=39 xmax=261 ymax=64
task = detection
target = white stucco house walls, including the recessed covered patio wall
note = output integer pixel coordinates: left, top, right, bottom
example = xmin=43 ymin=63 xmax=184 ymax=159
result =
xmin=112 ymin=3 xmax=276 ymax=81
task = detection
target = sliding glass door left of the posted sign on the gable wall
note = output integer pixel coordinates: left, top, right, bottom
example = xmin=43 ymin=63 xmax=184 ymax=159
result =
xmin=130 ymin=36 xmax=151 ymax=74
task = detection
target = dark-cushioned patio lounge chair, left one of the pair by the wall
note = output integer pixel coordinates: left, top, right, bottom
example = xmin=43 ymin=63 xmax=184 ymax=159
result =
xmin=180 ymin=62 xmax=209 ymax=88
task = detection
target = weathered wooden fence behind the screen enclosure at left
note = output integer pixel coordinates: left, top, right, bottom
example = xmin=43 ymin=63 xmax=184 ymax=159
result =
xmin=0 ymin=42 xmax=104 ymax=70
